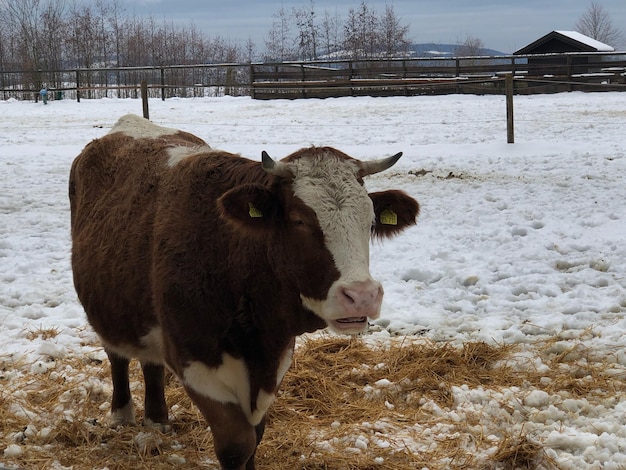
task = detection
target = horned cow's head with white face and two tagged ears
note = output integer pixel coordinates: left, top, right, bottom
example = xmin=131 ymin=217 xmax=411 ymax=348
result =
xmin=220 ymin=147 xmax=419 ymax=333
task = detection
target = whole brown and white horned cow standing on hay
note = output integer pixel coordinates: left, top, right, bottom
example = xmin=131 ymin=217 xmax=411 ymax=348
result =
xmin=69 ymin=115 xmax=419 ymax=470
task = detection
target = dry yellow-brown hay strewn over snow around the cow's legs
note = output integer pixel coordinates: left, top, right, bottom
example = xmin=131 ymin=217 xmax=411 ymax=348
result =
xmin=0 ymin=332 xmax=626 ymax=470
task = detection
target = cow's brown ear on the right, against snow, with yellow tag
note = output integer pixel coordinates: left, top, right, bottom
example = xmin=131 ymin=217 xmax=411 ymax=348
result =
xmin=369 ymin=190 xmax=420 ymax=238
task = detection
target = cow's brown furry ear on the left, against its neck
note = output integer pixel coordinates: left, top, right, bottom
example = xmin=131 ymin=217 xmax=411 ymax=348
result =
xmin=217 ymin=184 xmax=279 ymax=235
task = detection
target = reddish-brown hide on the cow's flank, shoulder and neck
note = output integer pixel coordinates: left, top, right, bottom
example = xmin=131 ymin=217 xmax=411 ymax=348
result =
xmin=70 ymin=133 xmax=326 ymax=369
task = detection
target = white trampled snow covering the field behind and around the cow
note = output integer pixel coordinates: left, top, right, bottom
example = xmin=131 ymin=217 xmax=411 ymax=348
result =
xmin=0 ymin=93 xmax=626 ymax=469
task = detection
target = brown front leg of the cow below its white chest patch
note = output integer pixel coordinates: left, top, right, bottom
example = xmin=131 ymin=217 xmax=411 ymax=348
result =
xmin=186 ymin=387 xmax=262 ymax=470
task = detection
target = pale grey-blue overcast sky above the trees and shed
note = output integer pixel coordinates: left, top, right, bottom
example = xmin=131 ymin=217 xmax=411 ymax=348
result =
xmin=120 ymin=0 xmax=626 ymax=53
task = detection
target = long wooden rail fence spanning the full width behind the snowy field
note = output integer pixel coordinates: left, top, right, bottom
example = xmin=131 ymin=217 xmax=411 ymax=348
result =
xmin=0 ymin=52 xmax=626 ymax=101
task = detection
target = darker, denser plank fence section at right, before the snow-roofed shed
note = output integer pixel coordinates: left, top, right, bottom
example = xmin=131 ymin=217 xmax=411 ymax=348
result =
xmin=250 ymin=52 xmax=626 ymax=99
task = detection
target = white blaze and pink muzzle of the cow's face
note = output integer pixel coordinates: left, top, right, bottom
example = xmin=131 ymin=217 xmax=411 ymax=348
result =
xmin=282 ymin=154 xmax=383 ymax=333
